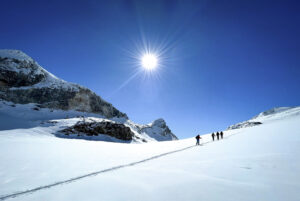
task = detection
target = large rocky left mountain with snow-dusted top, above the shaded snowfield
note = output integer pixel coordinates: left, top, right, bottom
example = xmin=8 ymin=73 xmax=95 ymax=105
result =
xmin=0 ymin=50 xmax=128 ymax=119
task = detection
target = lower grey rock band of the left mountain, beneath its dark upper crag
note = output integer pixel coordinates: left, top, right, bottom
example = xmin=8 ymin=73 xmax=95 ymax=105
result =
xmin=0 ymin=87 xmax=127 ymax=118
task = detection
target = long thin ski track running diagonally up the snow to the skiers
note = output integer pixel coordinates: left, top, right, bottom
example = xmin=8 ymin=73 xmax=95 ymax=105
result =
xmin=0 ymin=141 xmax=204 ymax=200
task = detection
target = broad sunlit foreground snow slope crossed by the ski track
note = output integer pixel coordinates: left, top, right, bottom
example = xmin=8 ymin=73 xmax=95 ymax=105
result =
xmin=0 ymin=107 xmax=300 ymax=201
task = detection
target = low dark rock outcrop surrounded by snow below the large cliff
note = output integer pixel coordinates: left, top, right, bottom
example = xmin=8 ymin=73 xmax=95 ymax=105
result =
xmin=61 ymin=121 xmax=134 ymax=141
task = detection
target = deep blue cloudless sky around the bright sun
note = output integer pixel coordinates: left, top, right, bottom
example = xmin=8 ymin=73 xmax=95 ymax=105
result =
xmin=0 ymin=0 xmax=300 ymax=138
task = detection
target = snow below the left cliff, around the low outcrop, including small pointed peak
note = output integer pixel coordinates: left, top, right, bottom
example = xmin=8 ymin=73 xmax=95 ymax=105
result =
xmin=0 ymin=100 xmax=177 ymax=143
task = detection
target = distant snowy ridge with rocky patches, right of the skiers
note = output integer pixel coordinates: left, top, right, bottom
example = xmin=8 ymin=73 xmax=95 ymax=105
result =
xmin=227 ymin=107 xmax=300 ymax=130
